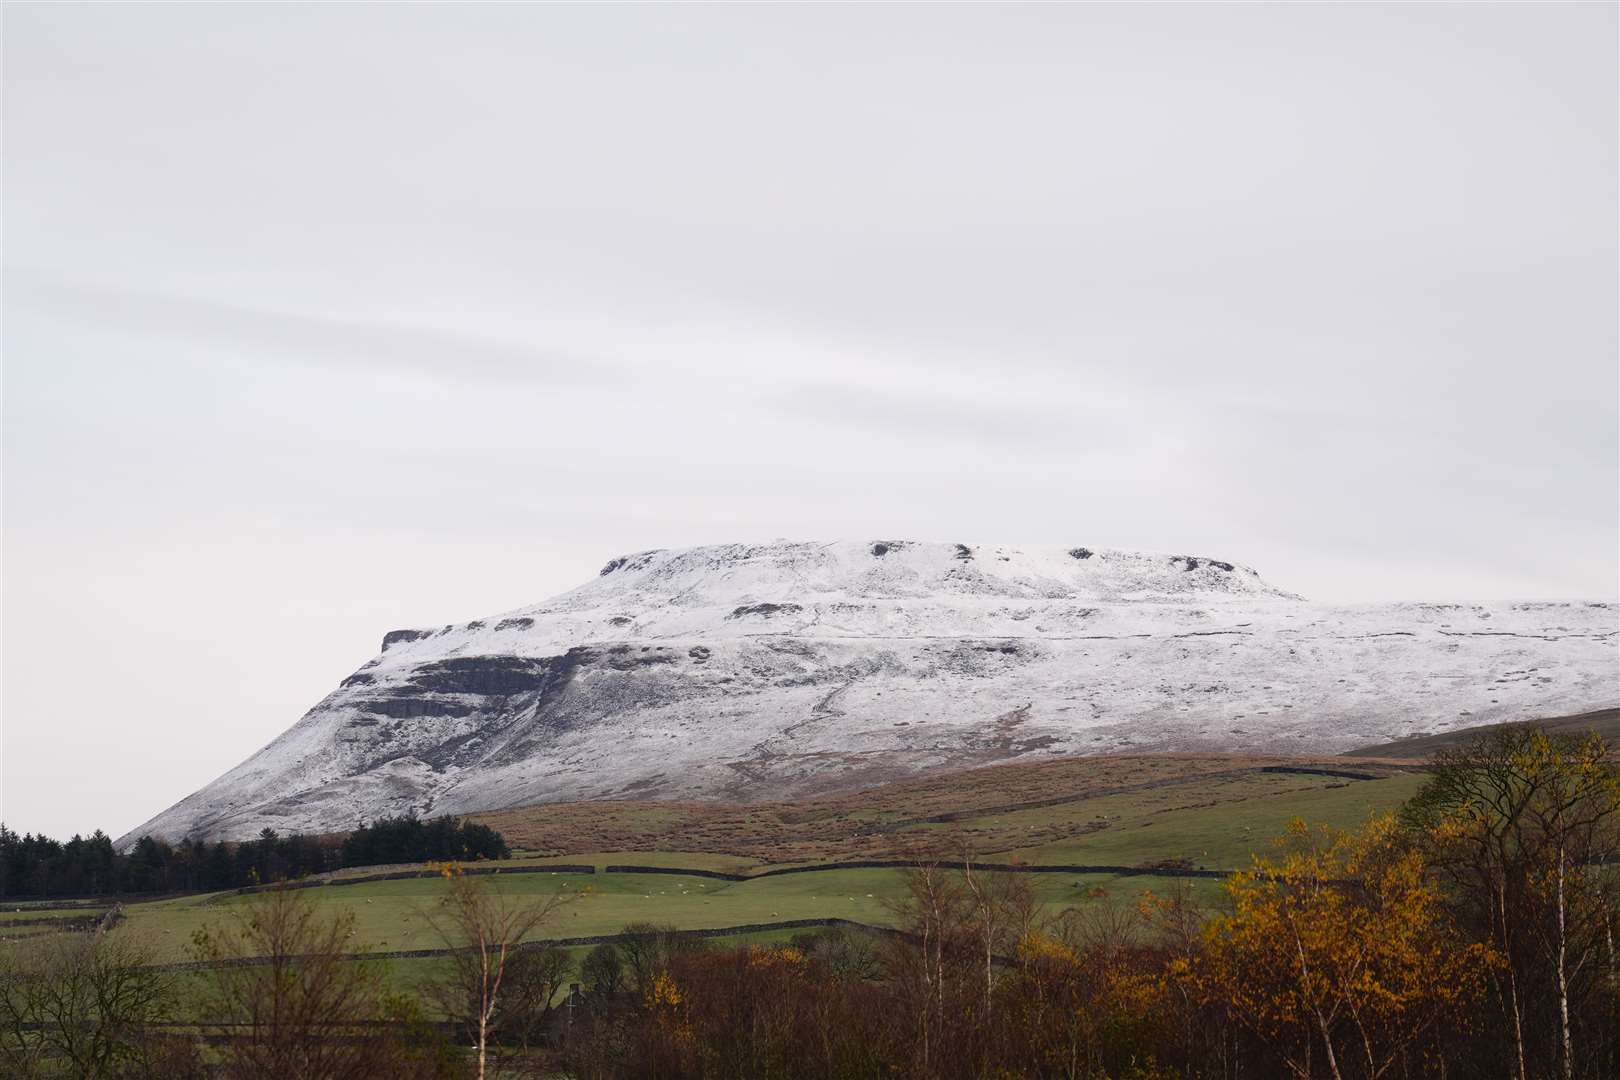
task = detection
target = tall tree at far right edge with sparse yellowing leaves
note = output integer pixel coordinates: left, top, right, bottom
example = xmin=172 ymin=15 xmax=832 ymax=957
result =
xmin=1403 ymin=725 xmax=1620 ymax=1080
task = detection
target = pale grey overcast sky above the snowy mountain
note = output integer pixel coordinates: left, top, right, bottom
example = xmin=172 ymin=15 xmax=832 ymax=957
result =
xmin=0 ymin=3 xmax=1620 ymax=836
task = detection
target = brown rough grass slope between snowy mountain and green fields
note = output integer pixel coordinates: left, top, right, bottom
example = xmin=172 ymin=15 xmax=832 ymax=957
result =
xmin=475 ymin=755 xmax=1408 ymax=866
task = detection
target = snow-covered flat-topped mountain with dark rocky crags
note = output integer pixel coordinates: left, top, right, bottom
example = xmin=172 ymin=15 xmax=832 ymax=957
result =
xmin=125 ymin=541 xmax=1620 ymax=840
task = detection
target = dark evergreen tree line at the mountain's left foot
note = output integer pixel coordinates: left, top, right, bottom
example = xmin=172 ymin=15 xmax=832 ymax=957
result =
xmin=0 ymin=814 xmax=510 ymax=900
